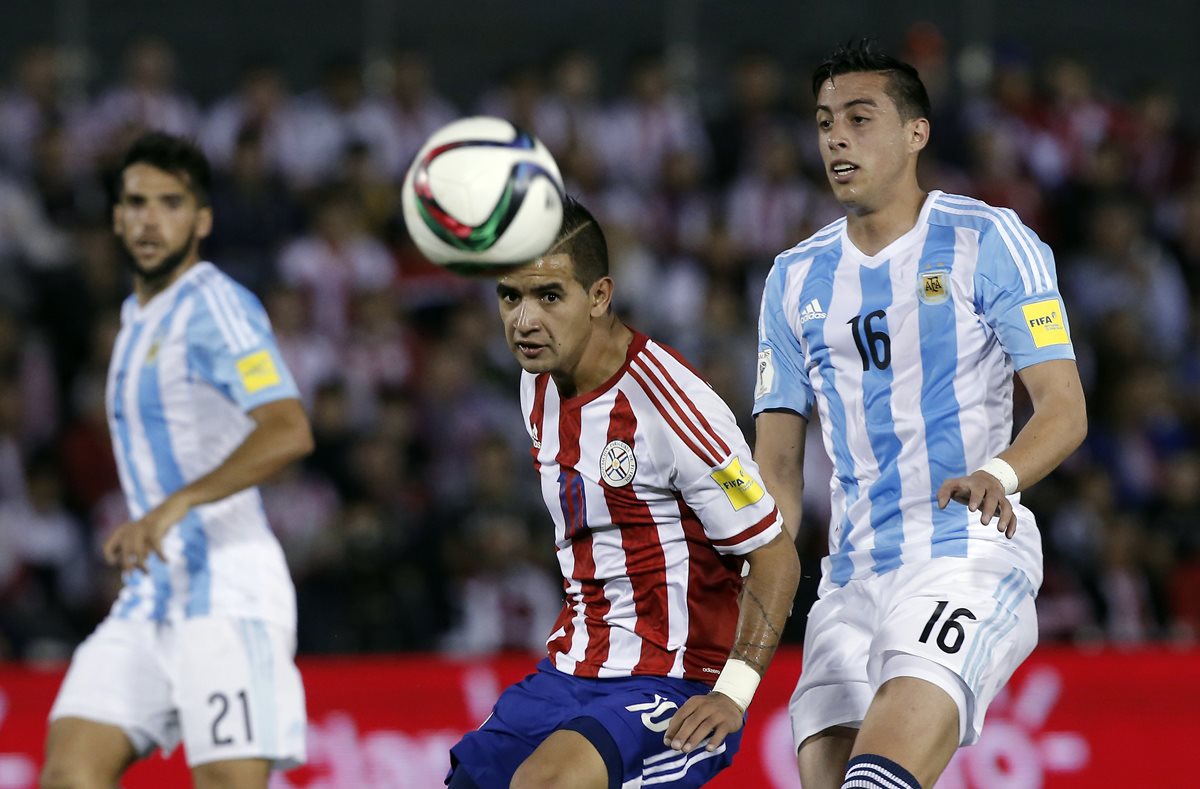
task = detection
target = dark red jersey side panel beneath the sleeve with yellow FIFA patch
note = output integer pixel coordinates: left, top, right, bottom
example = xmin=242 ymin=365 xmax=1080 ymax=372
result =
xmin=676 ymin=494 xmax=743 ymax=685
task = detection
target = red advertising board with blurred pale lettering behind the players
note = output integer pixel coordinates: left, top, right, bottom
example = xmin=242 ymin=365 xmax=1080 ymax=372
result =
xmin=0 ymin=649 xmax=1200 ymax=789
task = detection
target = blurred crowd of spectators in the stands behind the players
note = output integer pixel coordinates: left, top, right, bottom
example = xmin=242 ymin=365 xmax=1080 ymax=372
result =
xmin=0 ymin=26 xmax=1200 ymax=659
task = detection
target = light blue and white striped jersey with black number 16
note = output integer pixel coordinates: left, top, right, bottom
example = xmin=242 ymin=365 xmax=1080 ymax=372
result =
xmin=754 ymin=192 xmax=1074 ymax=590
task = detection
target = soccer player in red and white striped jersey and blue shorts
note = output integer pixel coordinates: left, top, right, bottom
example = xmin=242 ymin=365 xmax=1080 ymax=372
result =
xmin=448 ymin=199 xmax=799 ymax=789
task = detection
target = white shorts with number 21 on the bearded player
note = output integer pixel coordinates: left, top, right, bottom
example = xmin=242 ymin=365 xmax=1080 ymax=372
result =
xmin=50 ymin=616 xmax=307 ymax=770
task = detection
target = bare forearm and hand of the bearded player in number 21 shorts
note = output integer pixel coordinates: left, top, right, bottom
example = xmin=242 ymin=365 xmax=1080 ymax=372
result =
xmin=104 ymin=399 xmax=312 ymax=570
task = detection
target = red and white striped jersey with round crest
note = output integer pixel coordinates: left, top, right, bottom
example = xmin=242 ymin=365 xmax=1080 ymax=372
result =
xmin=521 ymin=332 xmax=782 ymax=682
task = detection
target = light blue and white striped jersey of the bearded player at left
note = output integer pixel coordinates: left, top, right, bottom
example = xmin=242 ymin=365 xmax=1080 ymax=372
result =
xmin=106 ymin=263 xmax=299 ymax=628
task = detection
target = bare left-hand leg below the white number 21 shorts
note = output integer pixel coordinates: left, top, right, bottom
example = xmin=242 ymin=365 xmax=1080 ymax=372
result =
xmin=40 ymin=717 xmax=138 ymax=789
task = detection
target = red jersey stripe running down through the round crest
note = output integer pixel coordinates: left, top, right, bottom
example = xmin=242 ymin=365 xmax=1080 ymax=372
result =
xmin=600 ymin=392 xmax=674 ymax=676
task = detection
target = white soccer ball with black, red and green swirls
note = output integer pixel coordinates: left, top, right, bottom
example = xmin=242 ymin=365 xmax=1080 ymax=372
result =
xmin=401 ymin=116 xmax=563 ymax=272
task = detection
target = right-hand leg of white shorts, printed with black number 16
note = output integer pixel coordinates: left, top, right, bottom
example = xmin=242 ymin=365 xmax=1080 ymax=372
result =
xmin=868 ymin=559 xmax=1037 ymax=745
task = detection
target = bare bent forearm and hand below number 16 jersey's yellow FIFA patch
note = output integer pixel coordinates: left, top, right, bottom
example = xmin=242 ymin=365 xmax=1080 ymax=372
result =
xmin=937 ymin=360 xmax=1087 ymax=537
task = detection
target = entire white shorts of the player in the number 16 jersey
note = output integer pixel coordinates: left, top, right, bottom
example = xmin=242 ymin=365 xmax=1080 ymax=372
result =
xmin=788 ymin=558 xmax=1038 ymax=748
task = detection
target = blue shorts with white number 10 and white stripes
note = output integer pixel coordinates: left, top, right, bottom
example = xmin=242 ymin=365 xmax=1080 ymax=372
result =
xmin=446 ymin=658 xmax=744 ymax=789
